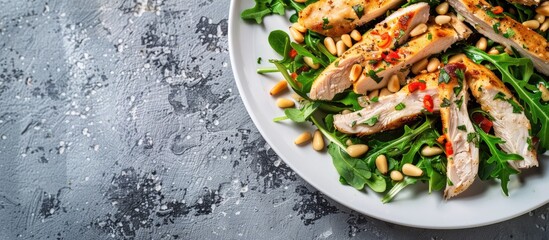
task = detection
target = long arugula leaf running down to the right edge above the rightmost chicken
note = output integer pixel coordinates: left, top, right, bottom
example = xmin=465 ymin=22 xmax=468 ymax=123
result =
xmin=464 ymin=46 xmax=549 ymax=149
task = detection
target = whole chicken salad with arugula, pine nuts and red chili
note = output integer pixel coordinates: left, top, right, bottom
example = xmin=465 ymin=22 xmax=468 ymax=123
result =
xmin=241 ymin=0 xmax=549 ymax=202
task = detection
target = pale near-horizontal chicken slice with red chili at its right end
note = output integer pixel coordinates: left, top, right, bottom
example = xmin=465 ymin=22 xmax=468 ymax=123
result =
xmin=334 ymin=72 xmax=440 ymax=136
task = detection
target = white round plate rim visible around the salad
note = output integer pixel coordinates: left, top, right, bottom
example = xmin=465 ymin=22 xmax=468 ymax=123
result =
xmin=229 ymin=0 xmax=549 ymax=229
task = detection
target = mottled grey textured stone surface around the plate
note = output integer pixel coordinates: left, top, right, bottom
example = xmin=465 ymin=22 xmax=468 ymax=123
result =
xmin=0 ymin=0 xmax=549 ymax=239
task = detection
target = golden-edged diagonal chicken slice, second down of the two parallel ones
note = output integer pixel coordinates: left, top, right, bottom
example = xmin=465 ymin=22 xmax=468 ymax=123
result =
xmin=353 ymin=15 xmax=471 ymax=94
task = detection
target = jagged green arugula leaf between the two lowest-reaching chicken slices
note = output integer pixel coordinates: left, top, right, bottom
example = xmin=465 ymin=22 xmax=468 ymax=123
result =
xmin=474 ymin=125 xmax=523 ymax=196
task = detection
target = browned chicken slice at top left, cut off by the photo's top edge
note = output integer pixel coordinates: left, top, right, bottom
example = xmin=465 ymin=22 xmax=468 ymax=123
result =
xmin=298 ymin=0 xmax=402 ymax=37
